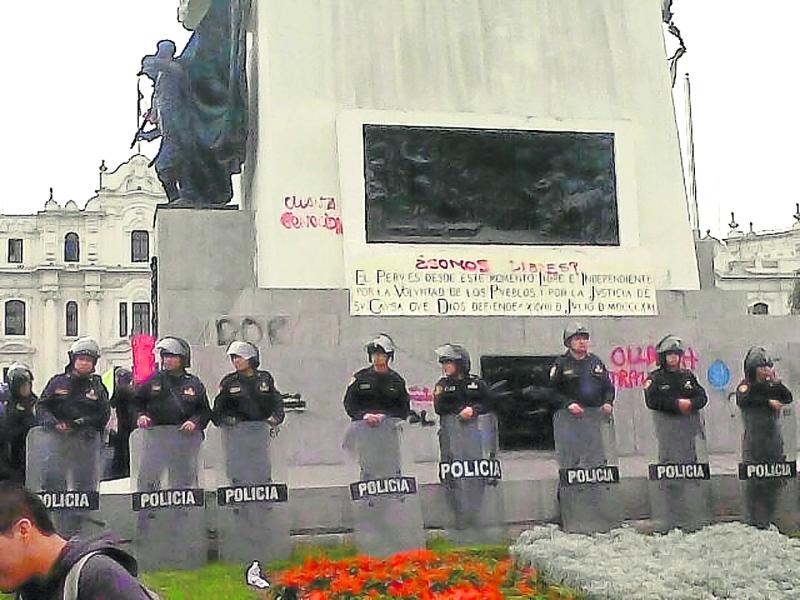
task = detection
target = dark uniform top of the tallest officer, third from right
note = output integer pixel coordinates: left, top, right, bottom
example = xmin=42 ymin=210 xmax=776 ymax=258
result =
xmin=550 ymin=352 xmax=614 ymax=409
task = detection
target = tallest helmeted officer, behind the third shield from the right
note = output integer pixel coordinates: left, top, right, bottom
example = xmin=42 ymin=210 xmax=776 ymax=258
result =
xmin=550 ymin=323 xmax=614 ymax=416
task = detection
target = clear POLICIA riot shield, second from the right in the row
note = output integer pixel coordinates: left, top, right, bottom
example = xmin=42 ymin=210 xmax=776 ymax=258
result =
xmin=648 ymin=411 xmax=711 ymax=531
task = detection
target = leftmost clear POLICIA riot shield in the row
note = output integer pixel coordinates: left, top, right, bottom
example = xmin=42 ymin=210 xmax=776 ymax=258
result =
xmin=25 ymin=427 xmax=104 ymax=537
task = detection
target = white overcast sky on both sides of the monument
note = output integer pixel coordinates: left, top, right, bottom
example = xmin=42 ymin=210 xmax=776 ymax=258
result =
xmin=0 ymin=0 xmax=800 ymax=234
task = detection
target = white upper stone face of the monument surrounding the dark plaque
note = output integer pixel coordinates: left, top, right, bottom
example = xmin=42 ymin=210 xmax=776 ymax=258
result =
xmin=250 ymin=0 xmax=699 ymax=290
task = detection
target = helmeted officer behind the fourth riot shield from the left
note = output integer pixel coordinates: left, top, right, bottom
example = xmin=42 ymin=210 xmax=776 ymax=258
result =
xmin=344 ymin=333 xmax=410 ymax=426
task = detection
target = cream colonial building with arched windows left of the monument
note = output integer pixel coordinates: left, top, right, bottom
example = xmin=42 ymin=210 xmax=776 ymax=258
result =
xmin=0 ymin=155 xmax=163 ymax=389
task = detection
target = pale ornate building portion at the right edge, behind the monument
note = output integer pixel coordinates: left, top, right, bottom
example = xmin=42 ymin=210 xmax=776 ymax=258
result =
xmin=714 ymin=207 xmax=800 ymax=315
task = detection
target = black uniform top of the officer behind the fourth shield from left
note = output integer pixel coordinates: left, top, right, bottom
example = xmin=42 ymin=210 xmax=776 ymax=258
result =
xmin=344 ymin=367 xmax=410 ymax=421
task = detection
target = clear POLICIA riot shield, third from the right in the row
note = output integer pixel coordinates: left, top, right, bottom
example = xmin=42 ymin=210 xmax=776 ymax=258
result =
xmin=553 ymin=408 xmax=622 ymax=533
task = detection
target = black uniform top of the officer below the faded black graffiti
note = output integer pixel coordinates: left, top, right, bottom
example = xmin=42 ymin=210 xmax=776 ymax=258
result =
xmin=211 ymin=370 xmax=284 ymax=425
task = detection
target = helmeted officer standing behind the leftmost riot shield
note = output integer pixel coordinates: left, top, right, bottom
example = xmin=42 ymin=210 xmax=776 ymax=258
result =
xmin=35 ymin=337 xmax=111 ymax=434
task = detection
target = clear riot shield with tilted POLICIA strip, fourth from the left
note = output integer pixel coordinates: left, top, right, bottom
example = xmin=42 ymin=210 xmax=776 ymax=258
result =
xmin=344 ymin=417 xmax=425 ymax=556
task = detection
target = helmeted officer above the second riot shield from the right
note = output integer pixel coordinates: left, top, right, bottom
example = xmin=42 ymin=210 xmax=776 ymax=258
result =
xmin=644 ymin=335 xmax=708 ymax=415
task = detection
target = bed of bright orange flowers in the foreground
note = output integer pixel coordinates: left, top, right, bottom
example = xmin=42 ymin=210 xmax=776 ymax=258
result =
xmin=271 ymin=550 xmax=575 ymax=600
